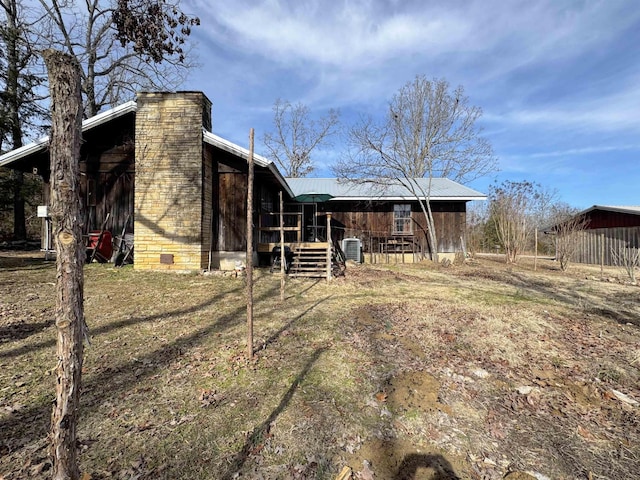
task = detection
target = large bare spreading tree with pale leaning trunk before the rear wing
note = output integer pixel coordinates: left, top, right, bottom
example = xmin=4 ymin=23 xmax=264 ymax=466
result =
xmin=334 ymin=76 xmax=496 ymax=262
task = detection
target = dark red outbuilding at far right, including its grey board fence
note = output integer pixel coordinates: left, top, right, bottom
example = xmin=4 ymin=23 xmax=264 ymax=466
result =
xmin=556 ymin=205 xmax=640 ymax=266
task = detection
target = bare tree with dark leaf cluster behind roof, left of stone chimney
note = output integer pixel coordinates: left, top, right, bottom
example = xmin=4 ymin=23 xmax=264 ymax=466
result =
xmin=39 ymin=0 xmax=200 ymax=117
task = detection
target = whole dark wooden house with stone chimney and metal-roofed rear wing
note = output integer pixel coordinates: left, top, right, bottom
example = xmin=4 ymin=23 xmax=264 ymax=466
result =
xmin=0 ymin=92 xmax=485 ymax=271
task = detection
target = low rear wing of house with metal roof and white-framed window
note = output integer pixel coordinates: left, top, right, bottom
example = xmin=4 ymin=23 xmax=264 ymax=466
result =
xmin=286 ymin=178 xmax=486 ymax=257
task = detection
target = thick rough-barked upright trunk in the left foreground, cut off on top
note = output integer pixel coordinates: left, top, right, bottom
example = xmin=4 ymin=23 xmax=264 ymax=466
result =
xmin=43 ymin=50 xmax=86 ymax=480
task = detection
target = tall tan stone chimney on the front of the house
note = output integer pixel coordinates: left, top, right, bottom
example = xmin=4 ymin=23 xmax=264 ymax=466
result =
xmin=134 ymin=92 xmax=211 ymax=271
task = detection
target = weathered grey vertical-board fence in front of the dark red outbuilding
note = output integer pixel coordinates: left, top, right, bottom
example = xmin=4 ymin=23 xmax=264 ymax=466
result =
xmin=573 ymin=227 xmax=640 ymax=266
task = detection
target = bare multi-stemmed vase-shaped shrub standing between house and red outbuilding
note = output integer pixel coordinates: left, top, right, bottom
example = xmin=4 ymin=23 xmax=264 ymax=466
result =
xmin=489 ymin=180 xmax=540 ymax=263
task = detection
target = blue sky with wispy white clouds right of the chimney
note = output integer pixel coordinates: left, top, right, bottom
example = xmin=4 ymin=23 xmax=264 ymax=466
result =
xmin=181 ymin=0 xmax=640 ymax=209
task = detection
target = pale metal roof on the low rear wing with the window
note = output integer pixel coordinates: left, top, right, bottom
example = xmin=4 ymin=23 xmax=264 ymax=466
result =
xmin=286 ymin=178 xmax=487 ymax=201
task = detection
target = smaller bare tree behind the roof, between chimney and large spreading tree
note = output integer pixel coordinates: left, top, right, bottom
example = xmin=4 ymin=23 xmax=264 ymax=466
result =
xmin=263 ymin=99 xmax=340 ymax=178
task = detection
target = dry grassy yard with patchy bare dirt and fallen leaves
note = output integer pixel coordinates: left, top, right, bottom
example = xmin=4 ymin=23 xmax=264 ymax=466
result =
xmin=0 ymin=252 xmax=640 ymax=480
